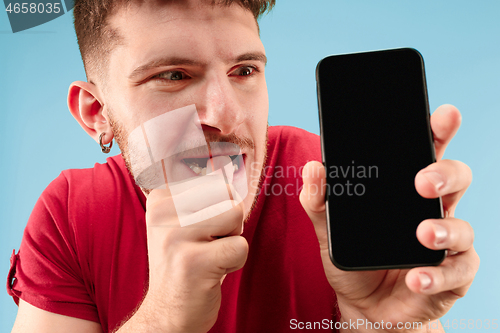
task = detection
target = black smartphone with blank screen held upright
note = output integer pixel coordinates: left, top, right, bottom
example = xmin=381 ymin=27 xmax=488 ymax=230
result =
xmin=316 ymin=48 xmax=446 ymax=270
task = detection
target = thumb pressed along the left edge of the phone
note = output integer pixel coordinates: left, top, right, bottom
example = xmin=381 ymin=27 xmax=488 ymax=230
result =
xmin=299 ymin=161 xmax=328 ymax=245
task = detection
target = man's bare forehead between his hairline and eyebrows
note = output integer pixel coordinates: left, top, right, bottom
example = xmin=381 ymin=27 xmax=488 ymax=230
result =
xmin=109 ymin=1 xmax=263 ymax=67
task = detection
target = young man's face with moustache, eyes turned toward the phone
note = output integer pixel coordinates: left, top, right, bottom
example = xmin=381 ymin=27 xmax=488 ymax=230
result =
xmin=105 ymin=1 xmax=268 ymax=215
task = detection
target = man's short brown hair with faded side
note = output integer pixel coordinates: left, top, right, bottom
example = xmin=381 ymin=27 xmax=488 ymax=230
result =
xmin=73 ymin=0 xmax=275 ymax=81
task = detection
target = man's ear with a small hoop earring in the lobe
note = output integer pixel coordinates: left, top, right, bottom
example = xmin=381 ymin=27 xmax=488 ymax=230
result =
xmin=68 ymin=81 xmax=113 ymax=145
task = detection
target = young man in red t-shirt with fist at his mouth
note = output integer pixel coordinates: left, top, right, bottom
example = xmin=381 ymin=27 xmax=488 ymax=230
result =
xmin=9 ymin=0 xmax=479 ymax=332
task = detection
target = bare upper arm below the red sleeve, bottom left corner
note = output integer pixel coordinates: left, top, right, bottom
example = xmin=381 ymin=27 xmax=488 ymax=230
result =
xmin=12 ymin=299 xmax=102 ymax=333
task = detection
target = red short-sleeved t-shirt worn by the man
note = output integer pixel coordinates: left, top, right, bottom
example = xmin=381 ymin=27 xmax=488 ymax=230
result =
xmin=7 ymin=127 xmax=339 ymax=333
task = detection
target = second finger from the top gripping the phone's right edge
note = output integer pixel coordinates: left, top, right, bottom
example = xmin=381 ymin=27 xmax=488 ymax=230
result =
xmin=415 ymin=160 xmax=472 ymax=211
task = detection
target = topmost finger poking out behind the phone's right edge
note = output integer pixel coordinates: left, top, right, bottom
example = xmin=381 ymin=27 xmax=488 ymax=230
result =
xmin=431 ymin=104 xmax=462 ymax=161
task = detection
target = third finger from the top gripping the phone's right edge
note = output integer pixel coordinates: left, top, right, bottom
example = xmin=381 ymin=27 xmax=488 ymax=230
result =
xmin=417 ymin=218 xmax=474 ymax=252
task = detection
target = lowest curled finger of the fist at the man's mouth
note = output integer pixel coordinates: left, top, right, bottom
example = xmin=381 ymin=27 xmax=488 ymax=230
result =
xmin=205 ymin=236 xmax=248 ymax=279
